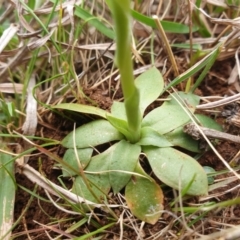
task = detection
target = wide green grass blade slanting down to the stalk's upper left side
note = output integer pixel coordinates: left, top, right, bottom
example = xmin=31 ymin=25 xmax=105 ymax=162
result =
xmin=74 ymin=5 xmax=115 ymax=39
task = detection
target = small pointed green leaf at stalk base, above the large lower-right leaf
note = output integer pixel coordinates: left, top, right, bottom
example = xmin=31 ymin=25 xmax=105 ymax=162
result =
xmin=136 ymin=127 xmax=173 ymax=147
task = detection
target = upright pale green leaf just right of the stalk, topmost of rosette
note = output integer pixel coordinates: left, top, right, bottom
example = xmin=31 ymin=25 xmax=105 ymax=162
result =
xmin=135 ymin=67 xmax=164 ymax=116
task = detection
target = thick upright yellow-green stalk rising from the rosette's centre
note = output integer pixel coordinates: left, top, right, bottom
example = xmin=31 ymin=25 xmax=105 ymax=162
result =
xmin=111 ymin=0 xmax=141 ymax=143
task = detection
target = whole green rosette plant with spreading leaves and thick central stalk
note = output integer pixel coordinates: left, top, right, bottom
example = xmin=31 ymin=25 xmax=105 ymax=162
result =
xmin=56 ymin=0 xmax=220 ymax=224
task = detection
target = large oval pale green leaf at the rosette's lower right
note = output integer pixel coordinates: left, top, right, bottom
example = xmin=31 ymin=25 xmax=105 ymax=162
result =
xmin=144 ymin=147 xmax=208 ymax=195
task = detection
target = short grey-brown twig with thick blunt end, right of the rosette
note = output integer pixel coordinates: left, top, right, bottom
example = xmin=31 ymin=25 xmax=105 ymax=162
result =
xmin=183 ymin=123 xmax=240 ymax=143
